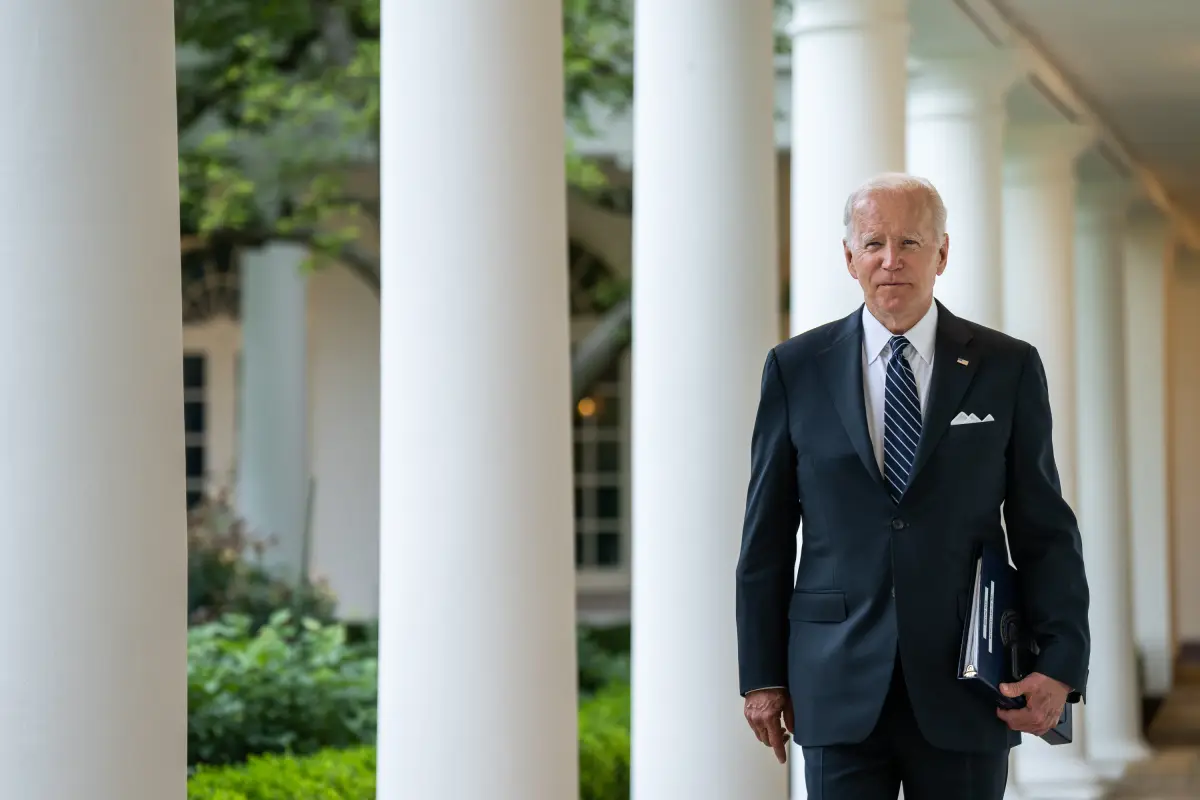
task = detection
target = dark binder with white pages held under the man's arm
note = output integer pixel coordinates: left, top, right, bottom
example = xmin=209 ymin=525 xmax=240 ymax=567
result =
xmin=958 ymin=545 xmax=1073 ymax=745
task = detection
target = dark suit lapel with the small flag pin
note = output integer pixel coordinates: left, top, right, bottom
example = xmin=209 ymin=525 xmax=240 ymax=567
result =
xmin=908 ymin=303 xmax=979 ymax=488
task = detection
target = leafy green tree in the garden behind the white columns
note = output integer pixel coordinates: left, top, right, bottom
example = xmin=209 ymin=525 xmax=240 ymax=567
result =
xmin=175 ymin=0 xmax=790 ymax=397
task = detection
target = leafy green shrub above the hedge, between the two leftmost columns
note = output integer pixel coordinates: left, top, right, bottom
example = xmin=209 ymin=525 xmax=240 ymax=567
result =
xmin=187 ymin=610 xmax=377 ymax=764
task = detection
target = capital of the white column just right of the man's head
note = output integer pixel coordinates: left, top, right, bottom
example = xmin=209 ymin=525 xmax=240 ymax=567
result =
xmin=908 ymin=50 xmax=1024 ymax=119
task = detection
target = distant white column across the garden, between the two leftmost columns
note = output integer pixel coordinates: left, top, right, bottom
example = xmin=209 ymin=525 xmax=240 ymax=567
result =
xmin=238 ymin=242 xmax=311 ymax=581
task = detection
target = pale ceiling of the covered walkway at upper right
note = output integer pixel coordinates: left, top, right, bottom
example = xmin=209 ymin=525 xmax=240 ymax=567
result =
xmin=910 ymin=0 xmax=1200 ymax=230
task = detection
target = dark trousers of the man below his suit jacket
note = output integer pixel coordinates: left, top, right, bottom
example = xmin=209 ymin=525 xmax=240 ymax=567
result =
xmin=804 ymin=658 xmax=1008 ymax=800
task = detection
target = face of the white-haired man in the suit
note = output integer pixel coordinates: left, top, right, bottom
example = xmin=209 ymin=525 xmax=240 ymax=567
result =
xmin=844 ymin=192 xmax=950 ymax=325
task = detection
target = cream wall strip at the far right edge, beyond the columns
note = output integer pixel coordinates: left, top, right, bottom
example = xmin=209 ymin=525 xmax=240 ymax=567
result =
xmin=1166 ymin=251 xmax=1200 ymax=643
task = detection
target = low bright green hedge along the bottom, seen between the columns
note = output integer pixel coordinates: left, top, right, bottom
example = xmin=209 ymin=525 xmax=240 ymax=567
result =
xmin=187 ymin=685 xmax=629 ymax=800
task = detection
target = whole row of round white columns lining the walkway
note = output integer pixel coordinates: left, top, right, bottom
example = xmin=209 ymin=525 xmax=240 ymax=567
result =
xmin=16 ymin=0 xmax=1170 ymax=800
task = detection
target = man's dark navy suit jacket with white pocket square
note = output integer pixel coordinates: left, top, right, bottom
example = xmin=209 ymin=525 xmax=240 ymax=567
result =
xmin=737 ymin=303 xmax=1090 ymax=752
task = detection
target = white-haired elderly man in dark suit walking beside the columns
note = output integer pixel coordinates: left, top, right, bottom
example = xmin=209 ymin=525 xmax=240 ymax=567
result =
xmin=737 ymin=174 xmax=1090 ymax=800
